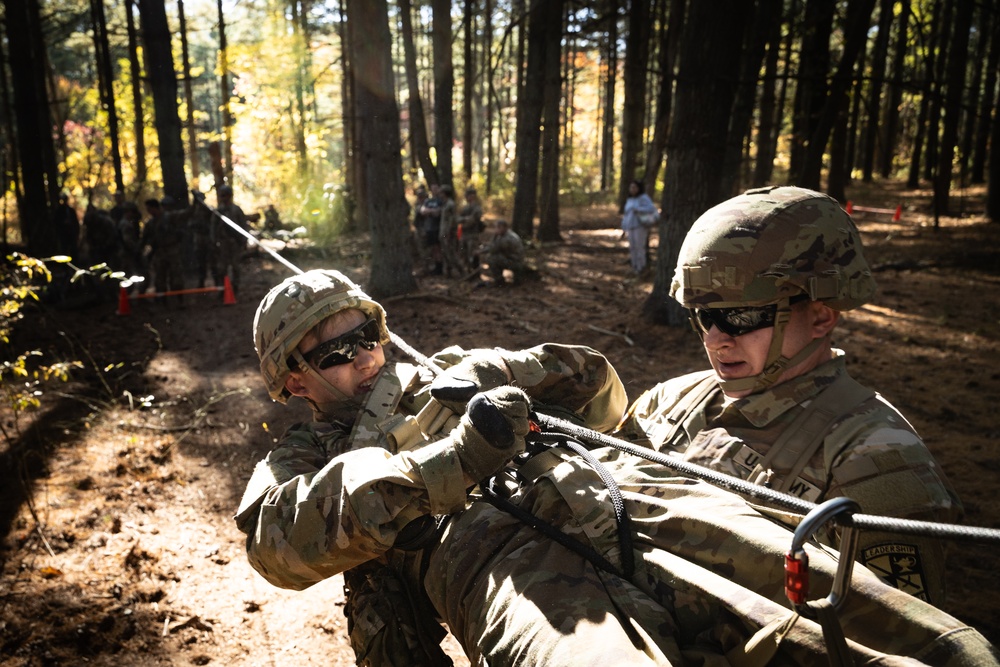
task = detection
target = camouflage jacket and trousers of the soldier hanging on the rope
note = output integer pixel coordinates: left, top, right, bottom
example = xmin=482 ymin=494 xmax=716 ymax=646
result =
xmin=236 ymin=345 xmax=998 ymax=666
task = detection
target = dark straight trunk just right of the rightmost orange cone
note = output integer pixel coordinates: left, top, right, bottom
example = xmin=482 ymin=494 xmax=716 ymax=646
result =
xmin=934 ymin=2 xmax=973 ymax=220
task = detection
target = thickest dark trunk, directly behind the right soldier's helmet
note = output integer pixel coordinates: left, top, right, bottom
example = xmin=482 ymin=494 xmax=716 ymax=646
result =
xmin=643 ymin=0 xmax=749 ymax=325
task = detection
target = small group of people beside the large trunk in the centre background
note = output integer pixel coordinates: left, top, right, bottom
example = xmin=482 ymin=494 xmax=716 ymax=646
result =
xmin=413 ymin=183 xmax=529 ymax=286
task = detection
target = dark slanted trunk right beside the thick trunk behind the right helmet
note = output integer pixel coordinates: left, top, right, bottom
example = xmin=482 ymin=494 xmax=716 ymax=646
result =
xmin=720 ymin=0 xmax=781 ymax=196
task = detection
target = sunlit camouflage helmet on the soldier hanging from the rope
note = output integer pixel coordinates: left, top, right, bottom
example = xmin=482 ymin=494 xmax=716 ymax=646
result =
xmin=253 ymin=269 xmax=389 ymax=403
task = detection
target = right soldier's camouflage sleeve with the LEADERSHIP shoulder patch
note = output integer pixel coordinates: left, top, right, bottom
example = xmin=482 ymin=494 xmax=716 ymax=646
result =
xmin=826 ymin=396 xmax=962 ymax=604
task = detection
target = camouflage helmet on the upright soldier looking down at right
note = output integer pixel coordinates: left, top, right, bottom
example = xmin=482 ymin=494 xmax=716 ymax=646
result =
xmin=670 ymin=187 xmax=876 ymax=310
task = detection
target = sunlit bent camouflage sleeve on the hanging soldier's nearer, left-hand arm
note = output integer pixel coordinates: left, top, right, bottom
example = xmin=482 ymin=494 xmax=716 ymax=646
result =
xmin=236 ymin=427 xmax=468 ymax=590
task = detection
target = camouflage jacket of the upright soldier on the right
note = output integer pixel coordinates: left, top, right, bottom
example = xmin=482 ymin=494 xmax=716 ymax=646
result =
xmin=620 ymin=350 xmax=961 ymax=603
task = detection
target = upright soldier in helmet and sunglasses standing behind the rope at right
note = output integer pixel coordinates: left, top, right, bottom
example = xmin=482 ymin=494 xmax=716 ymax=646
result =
xmin=622 ymin=187 xmax=961 ymax=604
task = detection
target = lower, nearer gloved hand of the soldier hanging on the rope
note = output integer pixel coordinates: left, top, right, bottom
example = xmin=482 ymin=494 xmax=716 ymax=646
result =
xmin=450 ymin=385 xmax=531 ymax=482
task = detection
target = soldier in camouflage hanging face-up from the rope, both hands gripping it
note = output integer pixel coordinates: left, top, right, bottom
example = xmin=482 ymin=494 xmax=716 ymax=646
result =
xmin=236 ymin=270 xmax=998 ymax=667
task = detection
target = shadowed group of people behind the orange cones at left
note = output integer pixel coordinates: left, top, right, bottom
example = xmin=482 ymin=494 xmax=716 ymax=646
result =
xmin=55 ymin=185 xmax=254 ymax=300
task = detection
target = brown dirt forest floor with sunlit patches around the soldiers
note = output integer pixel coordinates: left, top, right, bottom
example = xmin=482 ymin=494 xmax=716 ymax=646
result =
xmin=0 ymin=186 xmax=1000 ymax=666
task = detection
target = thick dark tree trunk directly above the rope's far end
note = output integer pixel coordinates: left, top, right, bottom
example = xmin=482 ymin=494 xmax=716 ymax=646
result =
xmin=139 ymin=0 xmax=188 ymax=205
